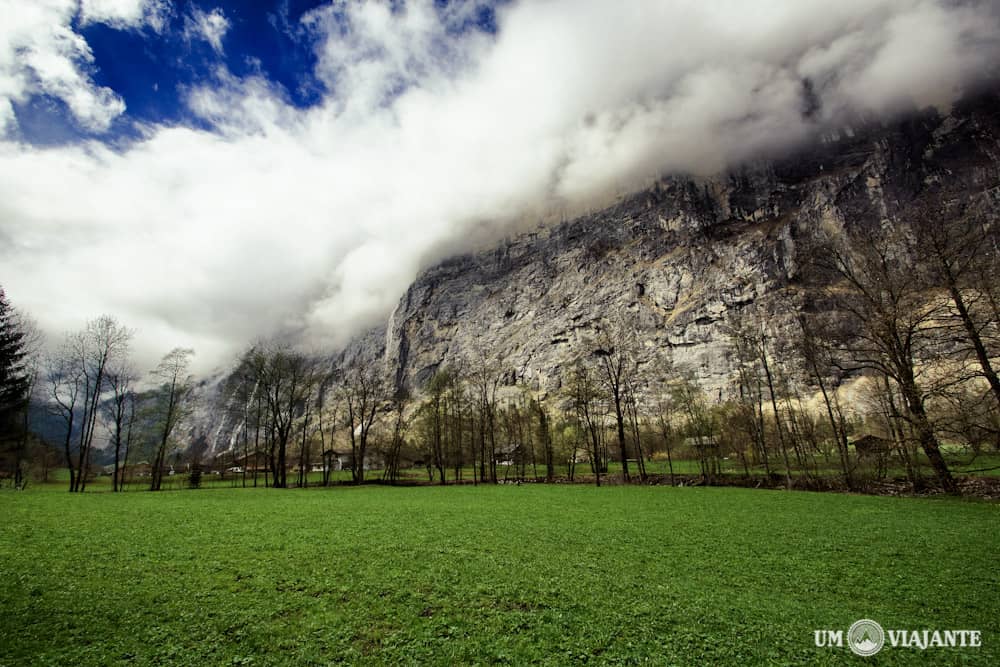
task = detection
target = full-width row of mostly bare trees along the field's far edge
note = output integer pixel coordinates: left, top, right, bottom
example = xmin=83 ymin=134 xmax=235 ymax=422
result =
xmin=0 ymin=193 xmax=1000 ymax=493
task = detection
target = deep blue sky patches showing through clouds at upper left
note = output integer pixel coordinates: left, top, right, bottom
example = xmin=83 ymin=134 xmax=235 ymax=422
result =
xmin=16 ymin=0 xmax=505 ymax=145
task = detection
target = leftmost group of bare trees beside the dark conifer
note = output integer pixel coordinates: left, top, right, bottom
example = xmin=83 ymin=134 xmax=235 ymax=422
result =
xmin=0 ymin=298 xmax=194 ymax=493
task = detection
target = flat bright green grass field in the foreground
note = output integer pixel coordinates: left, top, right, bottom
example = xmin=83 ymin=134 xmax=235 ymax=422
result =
xmin=0 ymin=485 xmax=1000 ymax=665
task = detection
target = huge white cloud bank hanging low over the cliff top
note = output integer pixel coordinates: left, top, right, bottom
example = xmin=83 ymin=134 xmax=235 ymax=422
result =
xmin=0 ymin=0 xmax=1000 ymax=376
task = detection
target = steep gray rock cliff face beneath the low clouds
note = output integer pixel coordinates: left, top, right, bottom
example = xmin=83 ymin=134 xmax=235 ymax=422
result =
xmin=374 ymin=95 xmax=1000 ymax=400
